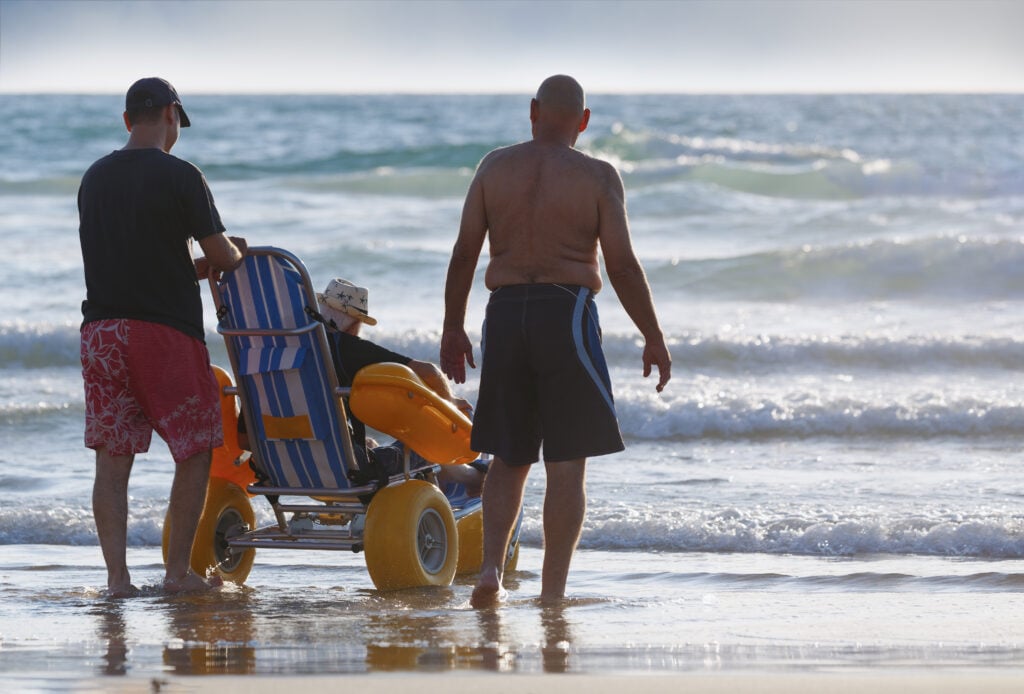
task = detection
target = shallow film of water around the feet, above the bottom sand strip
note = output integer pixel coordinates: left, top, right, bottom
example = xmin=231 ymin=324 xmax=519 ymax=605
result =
xmin=0 ymin=547 xmax=1024 ymax=684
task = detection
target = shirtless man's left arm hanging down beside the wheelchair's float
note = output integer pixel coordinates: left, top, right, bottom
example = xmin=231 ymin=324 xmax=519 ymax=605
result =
xmin=440 ymin=168 xmax=487 ymax=383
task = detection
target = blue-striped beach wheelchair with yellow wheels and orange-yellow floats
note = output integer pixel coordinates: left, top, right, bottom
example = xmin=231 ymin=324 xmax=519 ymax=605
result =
xmin=163 ymin=247 xmax=521 ymax=590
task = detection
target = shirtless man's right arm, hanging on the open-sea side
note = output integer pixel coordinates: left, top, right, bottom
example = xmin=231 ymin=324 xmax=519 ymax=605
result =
xmin=598 ymin=162 xmax=672 ymax=392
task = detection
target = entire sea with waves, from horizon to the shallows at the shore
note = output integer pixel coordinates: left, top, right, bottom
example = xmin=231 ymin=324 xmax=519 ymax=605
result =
xmin=0 ymin=95 xmax=1024 ymax=677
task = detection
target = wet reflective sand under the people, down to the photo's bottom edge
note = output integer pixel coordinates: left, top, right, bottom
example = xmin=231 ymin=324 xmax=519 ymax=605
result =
xmin=6 ymin=547 xmax=1024 ymax=694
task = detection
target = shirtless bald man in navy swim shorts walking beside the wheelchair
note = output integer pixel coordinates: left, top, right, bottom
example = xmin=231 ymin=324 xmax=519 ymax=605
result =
xmin=440 ymin=75 xmax=672 ymax=607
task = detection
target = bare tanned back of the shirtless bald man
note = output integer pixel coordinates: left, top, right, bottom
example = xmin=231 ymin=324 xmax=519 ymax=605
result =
xmin=477 ymin=140 xmax=615 ymax=292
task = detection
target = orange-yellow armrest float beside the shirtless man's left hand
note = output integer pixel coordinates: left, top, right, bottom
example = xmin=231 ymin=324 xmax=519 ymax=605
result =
xmin=348 ymin=362 xmax=478 ymax=465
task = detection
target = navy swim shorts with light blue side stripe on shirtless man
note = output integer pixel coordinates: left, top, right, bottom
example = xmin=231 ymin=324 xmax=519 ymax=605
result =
xmin=472 ymin=285 xmax=625 ymax=465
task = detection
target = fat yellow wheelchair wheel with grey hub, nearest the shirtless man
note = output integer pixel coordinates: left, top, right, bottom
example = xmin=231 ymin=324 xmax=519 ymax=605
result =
xmin=362 ymin=480 xmax=459 ymax=591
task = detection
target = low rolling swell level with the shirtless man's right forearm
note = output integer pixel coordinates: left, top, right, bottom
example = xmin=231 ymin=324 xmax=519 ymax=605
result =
xmin=647 ymin=235 xmax=1024 ymax=302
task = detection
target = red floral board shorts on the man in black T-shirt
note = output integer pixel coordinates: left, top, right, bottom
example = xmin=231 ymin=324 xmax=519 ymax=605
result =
xmin=82 ymin=319 xmax=224 ymax=462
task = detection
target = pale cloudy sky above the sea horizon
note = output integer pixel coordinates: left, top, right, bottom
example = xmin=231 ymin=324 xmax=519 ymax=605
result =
xmin=0 ymin=0 xmax=1024 ymax=94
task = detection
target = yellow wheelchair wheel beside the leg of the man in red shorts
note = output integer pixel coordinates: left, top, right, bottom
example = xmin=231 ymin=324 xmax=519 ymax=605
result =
xmin=163 ymin=477 xmax=256 ymax=584
